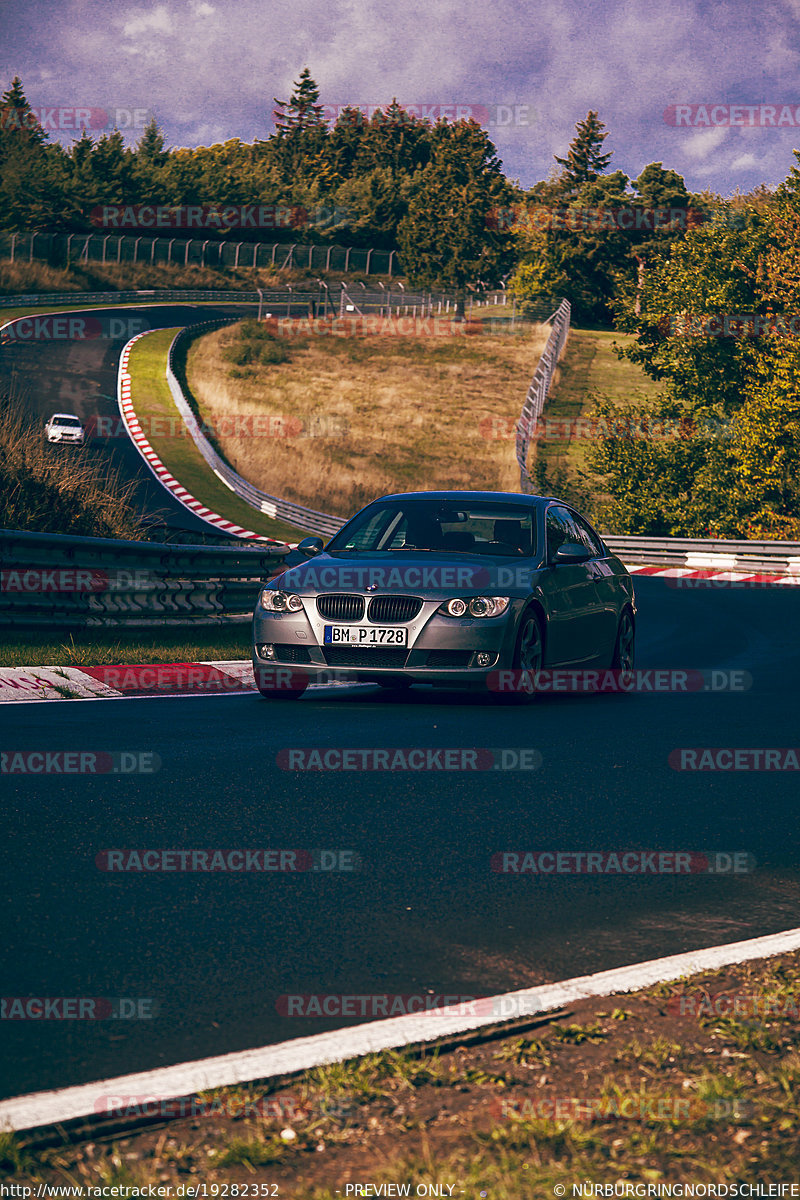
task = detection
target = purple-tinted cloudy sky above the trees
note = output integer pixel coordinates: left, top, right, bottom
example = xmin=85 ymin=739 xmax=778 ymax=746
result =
xmin=6 ymin=0 xmax=800 ymax=197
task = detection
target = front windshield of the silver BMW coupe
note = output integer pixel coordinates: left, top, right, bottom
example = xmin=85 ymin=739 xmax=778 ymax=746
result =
xmin=327 ymin=499 xmax=536 ymax=558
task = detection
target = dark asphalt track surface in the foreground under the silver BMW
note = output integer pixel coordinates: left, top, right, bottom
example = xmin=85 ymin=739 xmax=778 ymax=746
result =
xmin=0 ymin=578 xmax=800 ymax=1096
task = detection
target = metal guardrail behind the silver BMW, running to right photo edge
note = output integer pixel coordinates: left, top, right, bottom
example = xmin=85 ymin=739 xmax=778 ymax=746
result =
xmin=603 ymin=534 xmax=800 ymax=575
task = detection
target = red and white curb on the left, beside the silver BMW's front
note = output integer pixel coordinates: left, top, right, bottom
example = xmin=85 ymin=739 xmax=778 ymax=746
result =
xmin=0 ymin=659 xmax=255 ymax=704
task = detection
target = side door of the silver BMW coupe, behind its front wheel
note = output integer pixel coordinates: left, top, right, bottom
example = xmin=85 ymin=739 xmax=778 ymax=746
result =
xmin=542 ymin=504 xmax=602 ymax=666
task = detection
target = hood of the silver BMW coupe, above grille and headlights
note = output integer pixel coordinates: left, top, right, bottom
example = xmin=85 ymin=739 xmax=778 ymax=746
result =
xmin=270 ymin=551 xmax=540 ymax=596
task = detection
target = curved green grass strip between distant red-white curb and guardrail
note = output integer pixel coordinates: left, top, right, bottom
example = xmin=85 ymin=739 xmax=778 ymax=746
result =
xmin=128 ymin=329 xmax=307 ymax=541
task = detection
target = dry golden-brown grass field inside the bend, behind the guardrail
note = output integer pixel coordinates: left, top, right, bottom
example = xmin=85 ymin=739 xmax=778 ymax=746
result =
xmin=187 ymin=325 xmax=549 ymax=516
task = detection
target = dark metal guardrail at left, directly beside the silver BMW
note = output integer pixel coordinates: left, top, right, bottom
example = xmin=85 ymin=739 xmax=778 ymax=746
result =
xmin=0 ymin=529 xmax=289 ymax=631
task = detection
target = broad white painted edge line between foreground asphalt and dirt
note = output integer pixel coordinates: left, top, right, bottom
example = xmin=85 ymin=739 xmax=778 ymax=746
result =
xmin=0 ymin=929 xmax=800 ymax=1130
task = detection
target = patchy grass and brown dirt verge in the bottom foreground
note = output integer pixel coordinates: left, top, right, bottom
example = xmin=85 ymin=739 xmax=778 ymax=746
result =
xmin=6 ymin=954 xmax=800 ymax=1200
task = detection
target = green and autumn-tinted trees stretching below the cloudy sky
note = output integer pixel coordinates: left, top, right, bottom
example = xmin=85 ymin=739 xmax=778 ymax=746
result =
xmin=0 ymin=70 xmax=800 ymax=539
